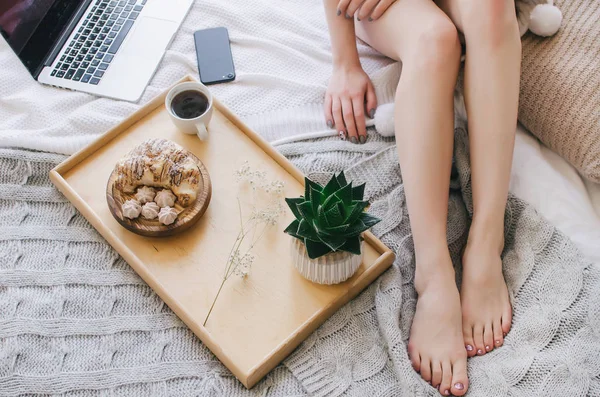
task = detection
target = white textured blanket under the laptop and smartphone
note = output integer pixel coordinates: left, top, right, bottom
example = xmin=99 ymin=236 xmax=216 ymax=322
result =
xmin=0 ymin=0 xmax=545 ymax=154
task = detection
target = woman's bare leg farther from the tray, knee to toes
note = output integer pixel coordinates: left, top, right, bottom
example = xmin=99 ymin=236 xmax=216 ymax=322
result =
xmin=438 ymin=0 xmax=521 ymax=356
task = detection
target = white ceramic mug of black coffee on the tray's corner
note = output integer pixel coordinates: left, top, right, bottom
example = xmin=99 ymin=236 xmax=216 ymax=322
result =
xmin=165 ymin=81 xmax=212 ymax=141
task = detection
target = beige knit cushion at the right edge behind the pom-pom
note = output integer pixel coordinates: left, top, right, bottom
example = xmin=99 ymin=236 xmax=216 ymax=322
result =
xmin=519 ymin=0 xmax=600 ymax=183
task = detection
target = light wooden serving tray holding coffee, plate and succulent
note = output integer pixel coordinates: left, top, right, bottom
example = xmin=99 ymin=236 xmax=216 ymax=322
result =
xmin=50 ymin=76 xmax=394 ymax=388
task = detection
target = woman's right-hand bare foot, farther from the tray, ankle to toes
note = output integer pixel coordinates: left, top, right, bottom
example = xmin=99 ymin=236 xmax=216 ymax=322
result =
xmin=460 ymin=234 xmax=512 ymax=357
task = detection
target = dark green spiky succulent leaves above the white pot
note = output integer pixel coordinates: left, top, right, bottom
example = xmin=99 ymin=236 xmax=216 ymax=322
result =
xmin=285 ymin=172 xmax=381 ymax=259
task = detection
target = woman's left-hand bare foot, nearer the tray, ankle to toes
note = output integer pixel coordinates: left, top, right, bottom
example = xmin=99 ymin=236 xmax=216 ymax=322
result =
xmin=408 ymin=252 xmax=469 ymax=396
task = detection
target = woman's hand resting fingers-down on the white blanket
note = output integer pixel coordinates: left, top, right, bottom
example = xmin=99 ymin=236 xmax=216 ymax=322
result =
xmin=325 ymin=64 xmax=377 ymax=143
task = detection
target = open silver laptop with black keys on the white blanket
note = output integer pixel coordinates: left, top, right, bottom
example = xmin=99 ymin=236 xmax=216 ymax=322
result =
xmin=0 ymin=0 xmax=193 ymax=101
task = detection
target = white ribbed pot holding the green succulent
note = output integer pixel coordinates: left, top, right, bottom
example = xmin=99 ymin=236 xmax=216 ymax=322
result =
xmin=290 ymin=238 xmax=363 ymax=285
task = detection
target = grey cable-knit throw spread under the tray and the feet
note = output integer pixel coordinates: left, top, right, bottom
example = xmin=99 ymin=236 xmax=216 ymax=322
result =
xmin=0 ymin=116 xmax=600 ymax=397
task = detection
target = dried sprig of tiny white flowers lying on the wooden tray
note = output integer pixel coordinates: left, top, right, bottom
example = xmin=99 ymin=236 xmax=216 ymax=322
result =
xmin=203 ymin=162 xmax=285 ymax=326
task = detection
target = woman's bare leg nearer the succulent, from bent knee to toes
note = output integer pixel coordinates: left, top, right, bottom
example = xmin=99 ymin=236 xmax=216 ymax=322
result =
xmin=357 ymin=0 xmax=468 ymax=396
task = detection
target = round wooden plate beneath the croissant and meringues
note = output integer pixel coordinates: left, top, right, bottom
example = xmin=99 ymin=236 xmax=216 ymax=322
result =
xmin=106 ymin=152 xmax=212 ymax=237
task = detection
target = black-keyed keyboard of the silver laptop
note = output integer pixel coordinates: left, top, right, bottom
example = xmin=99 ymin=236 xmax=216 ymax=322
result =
xmin=50 ymin=0 xmax=147 ymax=85
